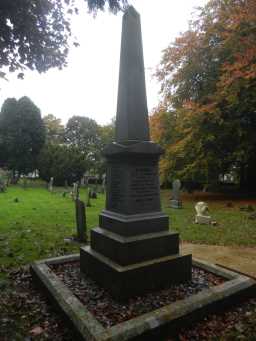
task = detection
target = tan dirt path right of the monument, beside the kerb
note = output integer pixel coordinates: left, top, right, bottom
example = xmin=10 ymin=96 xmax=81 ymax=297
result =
xmin=181 ymin=242 xmax=256 ymax=277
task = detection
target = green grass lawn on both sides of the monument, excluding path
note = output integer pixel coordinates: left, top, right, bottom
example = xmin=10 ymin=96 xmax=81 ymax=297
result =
xmin=0 ymin=186 xmax=256 ymax=267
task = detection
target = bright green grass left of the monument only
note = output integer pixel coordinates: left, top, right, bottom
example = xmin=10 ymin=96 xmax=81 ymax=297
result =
xmin=0 ymin=186 xmax=104 ymax=267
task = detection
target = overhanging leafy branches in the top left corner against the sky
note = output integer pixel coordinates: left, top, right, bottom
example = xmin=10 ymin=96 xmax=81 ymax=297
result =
xmin=0 ymin=0 xmax=126 ymax=78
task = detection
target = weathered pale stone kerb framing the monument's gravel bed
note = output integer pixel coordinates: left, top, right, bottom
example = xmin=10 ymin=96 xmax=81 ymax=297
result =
xmin=31 ymin=254 xmax=256 ymax=341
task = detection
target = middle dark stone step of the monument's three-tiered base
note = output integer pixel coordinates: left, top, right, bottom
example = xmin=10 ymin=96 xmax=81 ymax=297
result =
xmin=91 ymin=228 xmax=179 ymax=265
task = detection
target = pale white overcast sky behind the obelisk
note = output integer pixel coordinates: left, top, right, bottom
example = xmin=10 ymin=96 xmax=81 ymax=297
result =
xmin=0 ymin=0 xmax=207 ymax=124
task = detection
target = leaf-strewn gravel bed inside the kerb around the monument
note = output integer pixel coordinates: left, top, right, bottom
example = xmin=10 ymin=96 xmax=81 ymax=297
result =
xmin=50 ymin=261 xmax=225 ymax=328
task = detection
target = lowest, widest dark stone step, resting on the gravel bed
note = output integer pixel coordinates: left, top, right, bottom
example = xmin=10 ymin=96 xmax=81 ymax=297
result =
xmin=80 ymin=246 xmax=192 ymax=300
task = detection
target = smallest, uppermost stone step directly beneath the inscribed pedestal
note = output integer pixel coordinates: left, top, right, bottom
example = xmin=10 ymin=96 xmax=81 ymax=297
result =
xmin=99 ymin=210 xmax=169 ymax=236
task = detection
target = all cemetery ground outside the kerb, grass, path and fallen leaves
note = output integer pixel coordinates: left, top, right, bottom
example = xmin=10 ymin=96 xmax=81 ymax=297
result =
xmin=0 ymin=185 xmax=256 ymax=340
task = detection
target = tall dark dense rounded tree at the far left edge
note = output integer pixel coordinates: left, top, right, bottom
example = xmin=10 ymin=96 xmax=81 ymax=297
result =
xmin=0 ymin=97 xmax=45 ymax=174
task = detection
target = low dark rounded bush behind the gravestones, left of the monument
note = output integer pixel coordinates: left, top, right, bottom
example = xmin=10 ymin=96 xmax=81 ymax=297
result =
xmin=38 ymin=143 xmax=86 ymax=185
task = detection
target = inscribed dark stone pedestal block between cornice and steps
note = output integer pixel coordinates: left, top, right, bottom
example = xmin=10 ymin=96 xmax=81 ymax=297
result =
xmin=106 ymin=155 xmax=161 ymax=214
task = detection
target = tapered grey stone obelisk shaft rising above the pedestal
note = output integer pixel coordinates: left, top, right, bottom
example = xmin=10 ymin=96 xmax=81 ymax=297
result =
xmin=116 ymin=6 xmax=149 ymax=143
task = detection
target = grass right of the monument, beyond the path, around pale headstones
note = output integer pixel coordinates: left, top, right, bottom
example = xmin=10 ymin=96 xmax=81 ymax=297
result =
xmin=162 ymin=191 xmax=256 ymax=246
